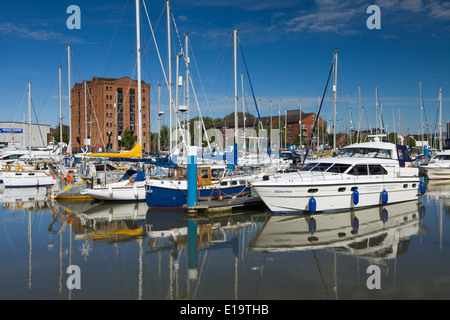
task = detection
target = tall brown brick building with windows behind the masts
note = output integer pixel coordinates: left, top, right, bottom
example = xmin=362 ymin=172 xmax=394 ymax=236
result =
xmin=71 ymin=77 xmax=151 ymax=153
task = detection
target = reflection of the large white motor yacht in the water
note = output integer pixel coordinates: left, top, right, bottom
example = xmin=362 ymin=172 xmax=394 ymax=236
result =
xmin=249 ymin=201 xmax=425 ymax=263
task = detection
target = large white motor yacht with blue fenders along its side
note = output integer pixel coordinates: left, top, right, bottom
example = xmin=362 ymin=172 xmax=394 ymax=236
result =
xmin=253 ymin=141 xmax=425 ymax=213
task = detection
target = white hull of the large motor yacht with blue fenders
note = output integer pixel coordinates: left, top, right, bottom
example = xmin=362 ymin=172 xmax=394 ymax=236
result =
xmin=253 ymin=178 xmax=420 ymax=213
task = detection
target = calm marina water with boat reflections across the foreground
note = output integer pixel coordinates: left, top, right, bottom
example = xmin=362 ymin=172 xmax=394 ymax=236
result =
xmin=0 ymin=182 xmax=450 ymax=300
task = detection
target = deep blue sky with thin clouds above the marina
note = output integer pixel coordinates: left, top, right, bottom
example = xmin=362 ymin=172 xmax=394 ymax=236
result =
xmin=0 ymin=0 xmax=450 ymax=133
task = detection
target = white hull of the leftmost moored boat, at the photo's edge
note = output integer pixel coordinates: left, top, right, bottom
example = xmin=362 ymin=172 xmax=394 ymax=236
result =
xmin=3 ymin=170 xmax=55 ymax=188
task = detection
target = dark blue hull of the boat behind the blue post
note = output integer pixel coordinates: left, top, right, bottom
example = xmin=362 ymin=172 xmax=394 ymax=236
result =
xmin=145 ymin=186 xmax=250 ymax=208
